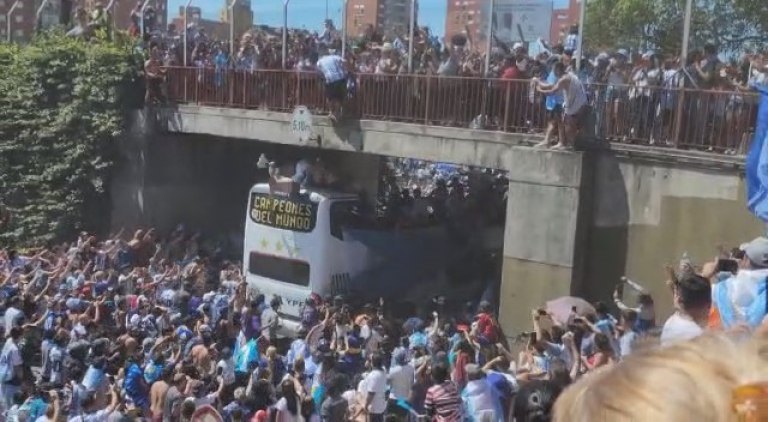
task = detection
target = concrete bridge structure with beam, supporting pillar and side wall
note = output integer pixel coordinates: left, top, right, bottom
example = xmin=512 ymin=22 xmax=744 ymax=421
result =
xmin=113 ymin=105 xmax=762 ymax=333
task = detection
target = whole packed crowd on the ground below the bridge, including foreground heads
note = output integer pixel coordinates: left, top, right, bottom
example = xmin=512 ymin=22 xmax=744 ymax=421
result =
xmin=0 ymin=219 xmax=768 ymax=422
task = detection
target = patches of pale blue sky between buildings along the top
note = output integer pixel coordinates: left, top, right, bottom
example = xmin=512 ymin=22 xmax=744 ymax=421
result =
xmin=168 ymin=0 xmax=567 ymax=35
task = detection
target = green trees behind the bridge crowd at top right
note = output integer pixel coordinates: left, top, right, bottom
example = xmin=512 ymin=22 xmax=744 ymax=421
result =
xmin=584 ymin=0 xmax=768 ymax=55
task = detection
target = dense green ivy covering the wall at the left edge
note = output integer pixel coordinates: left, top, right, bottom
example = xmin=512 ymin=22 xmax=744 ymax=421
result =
xmin=0 ymin=33 xmax=141 ymax=246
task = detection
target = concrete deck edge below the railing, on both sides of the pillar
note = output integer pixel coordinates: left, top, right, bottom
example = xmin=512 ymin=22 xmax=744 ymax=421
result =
xmin=159 ymin=104 xmax=744 ymax=173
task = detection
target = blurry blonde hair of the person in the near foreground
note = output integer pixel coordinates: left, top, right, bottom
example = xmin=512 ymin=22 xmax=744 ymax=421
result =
xmin=554 ymin=334 xmax=768 ymax=422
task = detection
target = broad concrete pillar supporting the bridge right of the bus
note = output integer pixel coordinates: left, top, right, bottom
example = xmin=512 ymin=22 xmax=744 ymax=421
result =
xmin=499 ymin=148 xmax=586 ymax=336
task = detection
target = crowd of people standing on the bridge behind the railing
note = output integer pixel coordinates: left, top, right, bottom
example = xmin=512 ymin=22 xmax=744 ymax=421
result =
xmin=142 ymin=15 xmax=768 ymax=154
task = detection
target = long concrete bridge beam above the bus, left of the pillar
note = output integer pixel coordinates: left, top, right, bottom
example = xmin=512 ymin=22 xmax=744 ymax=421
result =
xmin=160 ymin=105 xmax=538 ymax=170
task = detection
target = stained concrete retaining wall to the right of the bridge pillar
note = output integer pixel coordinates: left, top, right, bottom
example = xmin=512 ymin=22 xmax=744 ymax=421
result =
xmin=579 ymin=151 xmax=764 ymax=322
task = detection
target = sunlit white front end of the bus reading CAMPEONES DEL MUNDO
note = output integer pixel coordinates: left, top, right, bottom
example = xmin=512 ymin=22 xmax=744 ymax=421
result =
xmin=243 ymin=183 xmax=367 ymax=328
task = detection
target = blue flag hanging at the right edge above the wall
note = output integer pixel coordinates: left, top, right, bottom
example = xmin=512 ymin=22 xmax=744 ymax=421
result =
xmin=746 ymin=85 xmax=768 ymax=223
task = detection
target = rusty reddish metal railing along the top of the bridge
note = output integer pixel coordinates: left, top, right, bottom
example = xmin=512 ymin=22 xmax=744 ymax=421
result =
xmin=166 ymin=67 xmax=757 ymax=154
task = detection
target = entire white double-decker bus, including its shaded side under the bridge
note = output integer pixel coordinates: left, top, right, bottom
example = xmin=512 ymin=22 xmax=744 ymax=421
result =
xmin=243 ymin=179 xmax=503 ymax=332
